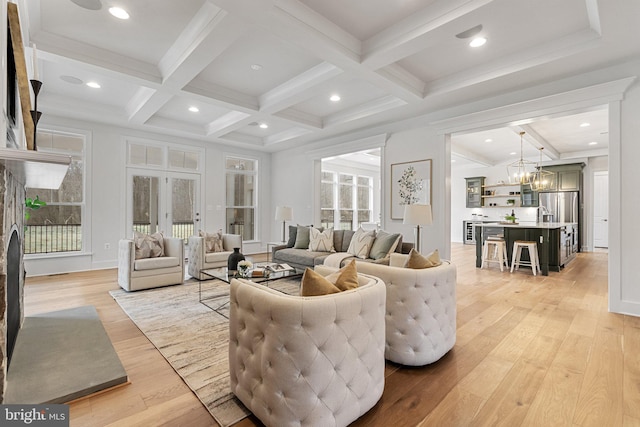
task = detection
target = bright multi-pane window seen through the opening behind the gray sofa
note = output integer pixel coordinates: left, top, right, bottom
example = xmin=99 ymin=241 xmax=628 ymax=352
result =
xmin=320 ymin=171 xmax=373 ymax=230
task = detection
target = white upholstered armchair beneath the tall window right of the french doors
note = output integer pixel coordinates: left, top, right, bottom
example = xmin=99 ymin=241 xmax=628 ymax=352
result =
xmin=187 ymin=234 xmax=242 ymax=280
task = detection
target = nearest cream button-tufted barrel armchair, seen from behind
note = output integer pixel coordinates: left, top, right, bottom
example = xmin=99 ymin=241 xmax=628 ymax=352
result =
xmin=229 ymin=275 xmax=385 ymax=427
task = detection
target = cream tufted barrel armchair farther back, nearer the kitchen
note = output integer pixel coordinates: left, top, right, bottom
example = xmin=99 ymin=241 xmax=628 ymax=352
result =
xmin=316 ymin=253 xmax=456 ymax=366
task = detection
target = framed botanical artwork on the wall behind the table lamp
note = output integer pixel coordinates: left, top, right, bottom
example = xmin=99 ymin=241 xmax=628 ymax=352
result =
xmin=391 ymin=159 xmax=431 ymax=219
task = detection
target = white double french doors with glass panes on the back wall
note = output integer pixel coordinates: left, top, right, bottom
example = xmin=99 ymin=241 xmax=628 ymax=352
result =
xmin=126 ymin=169 xmax=201 ymax=243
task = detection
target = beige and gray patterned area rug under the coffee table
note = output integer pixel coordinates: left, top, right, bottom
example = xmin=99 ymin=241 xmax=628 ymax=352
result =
xmin=110 ymin=279 xmax=300 ymax=427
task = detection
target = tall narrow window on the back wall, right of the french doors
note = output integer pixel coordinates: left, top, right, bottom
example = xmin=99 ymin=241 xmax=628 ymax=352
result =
xmin=225 ymin=157 xmax=258 ymax=240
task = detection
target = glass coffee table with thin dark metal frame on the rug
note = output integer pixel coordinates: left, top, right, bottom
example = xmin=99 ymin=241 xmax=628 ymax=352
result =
xmin=198 ymin=263 xmax=304 ymax=318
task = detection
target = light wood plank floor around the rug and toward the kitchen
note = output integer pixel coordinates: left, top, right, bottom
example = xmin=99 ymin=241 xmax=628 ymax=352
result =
xmin=25 ymin=244 xmax=640 ymax=427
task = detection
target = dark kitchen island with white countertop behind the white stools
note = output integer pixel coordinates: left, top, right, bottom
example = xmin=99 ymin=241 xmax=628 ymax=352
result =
xmin=476 ymin=222 xmax=578 ymax=276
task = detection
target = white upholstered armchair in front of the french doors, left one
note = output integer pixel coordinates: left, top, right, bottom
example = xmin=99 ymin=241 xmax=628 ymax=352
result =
xmin=118 ymin=237 xmax=184 ymax=291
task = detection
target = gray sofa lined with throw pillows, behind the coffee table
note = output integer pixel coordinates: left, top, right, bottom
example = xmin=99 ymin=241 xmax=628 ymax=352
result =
xmin=271 ymin=226 xmax=413 ymax=269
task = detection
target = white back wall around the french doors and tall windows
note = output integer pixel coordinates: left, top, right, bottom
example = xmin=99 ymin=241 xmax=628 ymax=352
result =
xmin=25 ymin=114 xmax=273 ymax=276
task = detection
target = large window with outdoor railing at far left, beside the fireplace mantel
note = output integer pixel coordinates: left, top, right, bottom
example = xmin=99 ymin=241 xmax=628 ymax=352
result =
xmin=24 ymin=130 xmax=85 ymax=254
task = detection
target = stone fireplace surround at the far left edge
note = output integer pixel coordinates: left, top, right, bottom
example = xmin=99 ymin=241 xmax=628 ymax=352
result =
xmin=0 ymin=164 xmax=26 ymax=402
